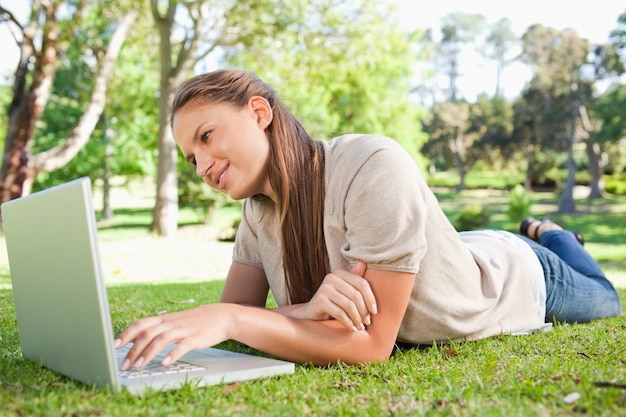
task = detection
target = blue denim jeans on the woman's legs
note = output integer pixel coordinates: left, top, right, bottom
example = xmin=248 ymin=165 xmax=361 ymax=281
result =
xmin=520 ymin=230 xmax=622 ymax=323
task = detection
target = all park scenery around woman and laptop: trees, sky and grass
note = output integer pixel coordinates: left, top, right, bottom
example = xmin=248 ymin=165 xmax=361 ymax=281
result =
xmin=0 ymin=0 xmax=626 ymax=415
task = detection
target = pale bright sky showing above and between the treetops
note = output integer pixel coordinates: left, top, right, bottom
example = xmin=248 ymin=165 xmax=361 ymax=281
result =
xmin=0 ymin=0 xmax=626 ymax=100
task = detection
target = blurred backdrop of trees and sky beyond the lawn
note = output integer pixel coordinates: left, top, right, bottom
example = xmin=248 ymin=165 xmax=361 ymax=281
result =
xmin=0 ymin=0 xmax=626 ymax=286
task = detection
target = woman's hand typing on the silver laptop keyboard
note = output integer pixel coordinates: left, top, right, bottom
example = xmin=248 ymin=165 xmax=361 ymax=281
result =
xmin=115 ymin=304 xmax=232 ymax=370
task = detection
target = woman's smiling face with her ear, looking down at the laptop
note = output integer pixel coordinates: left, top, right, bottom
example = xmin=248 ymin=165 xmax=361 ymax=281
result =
xmin=172 ymin=96 xmax=276 ymax=201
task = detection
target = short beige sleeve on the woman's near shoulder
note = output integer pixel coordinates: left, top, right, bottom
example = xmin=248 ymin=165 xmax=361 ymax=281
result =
xmin=326 ymin=136 xmax=427 ymax=273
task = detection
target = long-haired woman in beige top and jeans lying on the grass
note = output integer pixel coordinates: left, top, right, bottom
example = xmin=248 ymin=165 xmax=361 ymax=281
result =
xmin=116 ymin=70 xmax=622 ymax=369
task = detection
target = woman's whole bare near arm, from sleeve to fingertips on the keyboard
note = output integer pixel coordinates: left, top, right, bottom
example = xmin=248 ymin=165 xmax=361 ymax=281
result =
xmin=116 ymin=269 xmax=415 ymax=369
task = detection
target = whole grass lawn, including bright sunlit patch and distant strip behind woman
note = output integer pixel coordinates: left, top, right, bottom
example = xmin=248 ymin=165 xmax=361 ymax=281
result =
xmin=0 ymin=186 xmax=626 ymax=417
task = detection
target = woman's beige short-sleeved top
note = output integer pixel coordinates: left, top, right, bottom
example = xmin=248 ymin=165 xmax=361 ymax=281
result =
xmin=233 ymin=135 xmax=544 ymax=344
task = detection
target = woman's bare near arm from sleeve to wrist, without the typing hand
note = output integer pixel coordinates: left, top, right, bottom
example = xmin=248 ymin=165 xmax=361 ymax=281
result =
xmin=231 ymin=269 xmax=415 ymax=366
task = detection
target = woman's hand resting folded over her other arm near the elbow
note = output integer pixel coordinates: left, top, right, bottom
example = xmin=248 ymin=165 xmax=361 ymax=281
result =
xmin=299 ymin=261 xmax=377 ymax=331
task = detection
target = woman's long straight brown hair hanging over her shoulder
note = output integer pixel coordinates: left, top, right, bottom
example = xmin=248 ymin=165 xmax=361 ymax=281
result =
xmin=172 ymin=69 xmax=330 ymax=304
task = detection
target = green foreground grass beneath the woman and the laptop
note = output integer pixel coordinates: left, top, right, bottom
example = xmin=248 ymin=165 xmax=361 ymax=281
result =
xmin=0 ymin=281 xmax=626 ymax=416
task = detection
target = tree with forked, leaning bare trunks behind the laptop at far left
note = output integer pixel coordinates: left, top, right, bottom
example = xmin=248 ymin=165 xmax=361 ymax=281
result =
xmin=0 ymin=0 xmax=136 ymax=211
